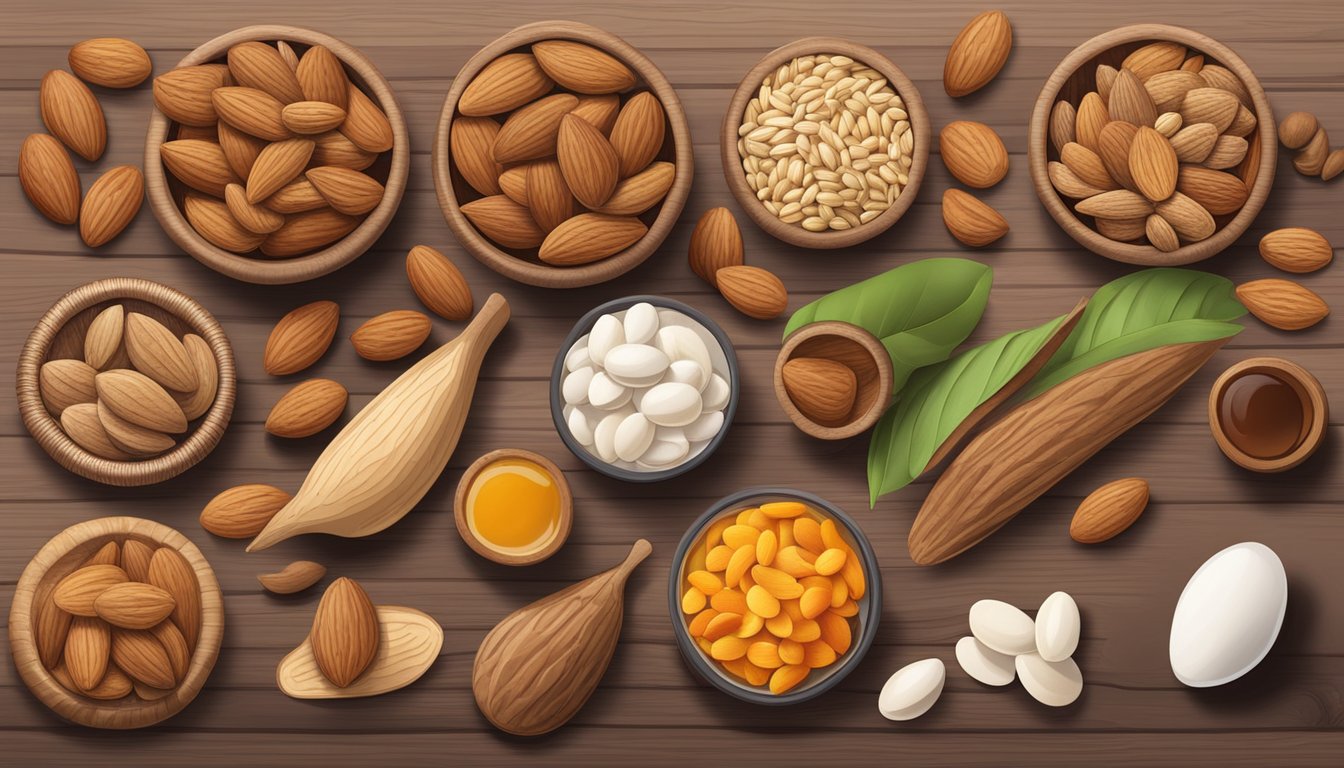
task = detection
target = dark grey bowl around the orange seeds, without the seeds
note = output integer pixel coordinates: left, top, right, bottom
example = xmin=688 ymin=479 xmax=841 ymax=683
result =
xmin=668 ymin=486 xmax=882 ymax=706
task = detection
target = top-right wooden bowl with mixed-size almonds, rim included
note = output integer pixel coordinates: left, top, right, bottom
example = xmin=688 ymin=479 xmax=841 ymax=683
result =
xmin=1028 ymin=24 xmax=1278 ymax=266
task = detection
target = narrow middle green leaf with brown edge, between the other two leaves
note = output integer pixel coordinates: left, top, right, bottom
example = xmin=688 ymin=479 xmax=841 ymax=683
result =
xmin=868 ymin=315 xmax=1068 ymax=504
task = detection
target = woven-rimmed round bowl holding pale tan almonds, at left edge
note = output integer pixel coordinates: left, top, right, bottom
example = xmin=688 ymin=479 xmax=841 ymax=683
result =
xmin=17 ymin=277 xmax=238 ymax=486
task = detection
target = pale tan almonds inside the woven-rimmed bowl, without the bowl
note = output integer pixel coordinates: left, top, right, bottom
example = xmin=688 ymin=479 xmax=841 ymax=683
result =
xmin=38 ymin=304 xmax=219 ymax=461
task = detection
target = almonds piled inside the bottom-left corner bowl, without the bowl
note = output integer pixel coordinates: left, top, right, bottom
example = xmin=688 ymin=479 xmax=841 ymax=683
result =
xmin=34 ymin=538 xmax=200 ymax=701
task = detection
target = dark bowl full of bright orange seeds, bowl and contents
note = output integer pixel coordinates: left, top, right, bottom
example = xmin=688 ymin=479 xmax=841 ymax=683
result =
xmin=668 ymin=487 xmax=882 ymax=706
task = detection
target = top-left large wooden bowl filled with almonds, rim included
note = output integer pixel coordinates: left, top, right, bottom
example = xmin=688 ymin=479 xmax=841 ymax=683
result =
xmin=145 ymin=24 xmax=411 ymax=284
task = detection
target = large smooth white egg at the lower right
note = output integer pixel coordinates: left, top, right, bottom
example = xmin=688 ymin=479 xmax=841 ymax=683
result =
xmin=1169 ymin=542 xmax=1288 ymax=687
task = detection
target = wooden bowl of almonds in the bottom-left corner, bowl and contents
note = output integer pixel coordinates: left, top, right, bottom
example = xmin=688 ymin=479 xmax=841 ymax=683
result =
xmin=9 ymin=518 xmax=224 ymax=729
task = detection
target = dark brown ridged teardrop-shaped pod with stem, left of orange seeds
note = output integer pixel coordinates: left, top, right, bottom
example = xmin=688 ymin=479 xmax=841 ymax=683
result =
xmin=472 ymin=539 xmax=653 ymax=736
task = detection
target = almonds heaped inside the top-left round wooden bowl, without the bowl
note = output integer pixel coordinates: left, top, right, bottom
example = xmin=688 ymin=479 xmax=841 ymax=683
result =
xmin=155 ymin=40 xmax=392 ymax=258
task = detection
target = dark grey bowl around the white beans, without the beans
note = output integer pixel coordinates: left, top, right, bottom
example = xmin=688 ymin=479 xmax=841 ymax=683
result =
xmin=551 ymin=296 xmax=742 ymax=483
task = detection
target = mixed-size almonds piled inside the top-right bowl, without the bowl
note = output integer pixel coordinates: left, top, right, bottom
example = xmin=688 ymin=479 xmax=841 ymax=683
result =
xmin=1048 ymin=42 xmax=1257 ymax=252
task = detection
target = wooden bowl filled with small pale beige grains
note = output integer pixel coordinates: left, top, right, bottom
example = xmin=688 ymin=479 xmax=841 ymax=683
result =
xmin=720 ymin=38 xmax=930 ymax=249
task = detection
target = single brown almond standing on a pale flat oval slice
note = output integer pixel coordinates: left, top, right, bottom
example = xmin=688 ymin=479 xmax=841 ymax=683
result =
xmin=308 ymin=577 xmax=379 ymax=687
